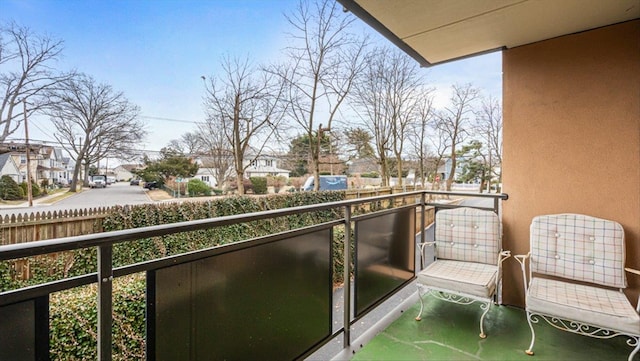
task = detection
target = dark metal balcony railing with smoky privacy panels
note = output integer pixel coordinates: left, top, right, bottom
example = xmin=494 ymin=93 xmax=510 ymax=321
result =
xmin=0 ymin=191 xmax=508 ymax=360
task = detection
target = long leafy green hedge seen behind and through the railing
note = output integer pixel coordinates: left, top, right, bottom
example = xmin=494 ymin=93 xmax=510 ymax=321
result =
xmin=0 ymin=187 xmax=432 ymax=360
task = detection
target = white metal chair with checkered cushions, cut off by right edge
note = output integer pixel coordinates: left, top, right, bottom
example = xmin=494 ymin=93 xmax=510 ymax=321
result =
xmin=515 ymin=214 xmax=640 ymax=360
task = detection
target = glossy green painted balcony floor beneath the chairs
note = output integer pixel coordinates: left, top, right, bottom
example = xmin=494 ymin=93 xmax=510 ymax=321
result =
xmin=352 ymin=297 xmax=640 ymax=361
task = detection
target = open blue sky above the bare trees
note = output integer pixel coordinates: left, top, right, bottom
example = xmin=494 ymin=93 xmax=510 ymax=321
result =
xmin=0 ymin=0 xmax=502 ymax=154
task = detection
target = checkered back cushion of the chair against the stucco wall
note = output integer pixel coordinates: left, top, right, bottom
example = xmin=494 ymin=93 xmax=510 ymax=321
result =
xmin=530 ymin=214 xmax=627 ymax=288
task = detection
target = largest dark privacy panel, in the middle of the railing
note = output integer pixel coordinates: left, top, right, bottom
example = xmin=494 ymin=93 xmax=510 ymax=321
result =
xmin=149 ymin=229 xmax=332 ymax=361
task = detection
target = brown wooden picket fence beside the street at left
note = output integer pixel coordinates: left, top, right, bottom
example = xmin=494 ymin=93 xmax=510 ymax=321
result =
xmin=0 ymin=207 xmax=112 ymax=245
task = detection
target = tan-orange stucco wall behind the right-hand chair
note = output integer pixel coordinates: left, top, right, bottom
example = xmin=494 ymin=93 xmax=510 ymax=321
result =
xmin=503 ymin=20 xmax=640 ymax=306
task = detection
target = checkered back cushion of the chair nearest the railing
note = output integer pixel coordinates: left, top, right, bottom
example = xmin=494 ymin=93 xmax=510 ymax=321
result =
xmin=436 ymin=208 xmax=502 ymax=264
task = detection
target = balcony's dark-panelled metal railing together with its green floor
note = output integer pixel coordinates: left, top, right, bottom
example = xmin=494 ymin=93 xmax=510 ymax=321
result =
xmin=0 ymin=191 xmax=630 ymax=360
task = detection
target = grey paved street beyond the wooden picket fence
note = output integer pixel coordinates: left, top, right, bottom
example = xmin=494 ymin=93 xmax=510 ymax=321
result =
xmin=0 ymin=182 xmax=151 ymax=217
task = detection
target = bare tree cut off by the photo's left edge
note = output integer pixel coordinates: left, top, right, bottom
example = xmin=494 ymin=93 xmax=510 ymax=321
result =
xmin=0 ymin=23 xmax=73 ymax=142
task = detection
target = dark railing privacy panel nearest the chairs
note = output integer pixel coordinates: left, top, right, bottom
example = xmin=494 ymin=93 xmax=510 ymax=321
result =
xmin=355 ymin=208 xmax=416 ymax=317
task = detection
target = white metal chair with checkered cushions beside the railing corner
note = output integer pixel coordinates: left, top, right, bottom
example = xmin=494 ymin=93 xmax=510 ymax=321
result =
xmin=416 ymin=207 xmax=510 ymax=338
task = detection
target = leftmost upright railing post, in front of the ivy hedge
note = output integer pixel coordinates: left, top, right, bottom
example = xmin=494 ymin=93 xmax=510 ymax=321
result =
xmin=98 ymin=245 xmax=113 ymax=361
